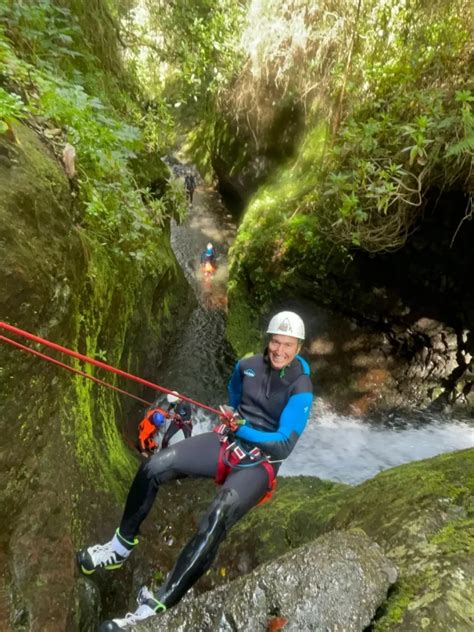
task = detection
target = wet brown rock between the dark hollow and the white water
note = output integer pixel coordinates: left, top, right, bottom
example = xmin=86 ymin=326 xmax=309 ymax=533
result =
xmin=300 ymin=296 xmax=474 ymax=416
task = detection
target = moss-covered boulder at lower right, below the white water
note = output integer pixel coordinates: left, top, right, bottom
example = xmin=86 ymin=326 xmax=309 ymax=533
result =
xmin=219 ymin=449 xmax=474 ymax=632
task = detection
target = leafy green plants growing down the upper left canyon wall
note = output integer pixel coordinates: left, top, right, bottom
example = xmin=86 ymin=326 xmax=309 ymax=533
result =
xmin=32 ymin=74 xmax=185 ymax=265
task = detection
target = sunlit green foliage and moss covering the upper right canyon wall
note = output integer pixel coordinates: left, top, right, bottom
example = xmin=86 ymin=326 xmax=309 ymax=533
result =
xmin=226 ymin=0 xmax=474 ymax=305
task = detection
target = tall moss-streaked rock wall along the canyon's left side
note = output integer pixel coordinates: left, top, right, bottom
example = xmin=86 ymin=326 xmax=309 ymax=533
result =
xmin=0 ymin=123 xmax=193 ymax=632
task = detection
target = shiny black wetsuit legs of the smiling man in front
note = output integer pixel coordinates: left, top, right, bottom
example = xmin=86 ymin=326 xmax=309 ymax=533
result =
xmin=120 ymin=432 xmax=274 ymax=607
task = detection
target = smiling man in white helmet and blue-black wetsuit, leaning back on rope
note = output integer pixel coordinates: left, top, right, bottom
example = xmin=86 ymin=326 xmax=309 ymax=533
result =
xmin=77 ymin=311 xmax=313 ymax=632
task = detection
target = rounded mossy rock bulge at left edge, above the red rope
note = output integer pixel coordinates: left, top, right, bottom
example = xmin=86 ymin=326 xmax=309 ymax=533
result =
xmin=0 ymin=119 xmax=84 ymax=328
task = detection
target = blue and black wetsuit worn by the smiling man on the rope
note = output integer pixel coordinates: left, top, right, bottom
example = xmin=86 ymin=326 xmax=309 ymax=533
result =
xmin=116 ymin=354 xmax=312 ymax=607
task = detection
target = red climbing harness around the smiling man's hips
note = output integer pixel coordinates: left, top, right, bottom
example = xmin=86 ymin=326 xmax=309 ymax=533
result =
xmin=213 ymin=424 xmax=277 ymax=505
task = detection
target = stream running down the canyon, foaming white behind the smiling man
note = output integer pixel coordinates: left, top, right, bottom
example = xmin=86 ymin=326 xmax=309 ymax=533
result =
xmin=157 ymin=168 xmax=474 ymax=484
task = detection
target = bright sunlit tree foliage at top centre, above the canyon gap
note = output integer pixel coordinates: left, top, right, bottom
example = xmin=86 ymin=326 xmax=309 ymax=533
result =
xmin=130 ymin=0 xmax=243 ymax=126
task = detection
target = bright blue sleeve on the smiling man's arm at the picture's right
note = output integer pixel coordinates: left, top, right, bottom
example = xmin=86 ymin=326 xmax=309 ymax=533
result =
xmin=235 ymin=392 xmax=313 ymax=460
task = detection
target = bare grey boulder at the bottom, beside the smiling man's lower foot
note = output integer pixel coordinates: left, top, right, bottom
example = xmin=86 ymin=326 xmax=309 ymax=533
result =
xmin=137 ymin=532 xmax=397 ymax=632
